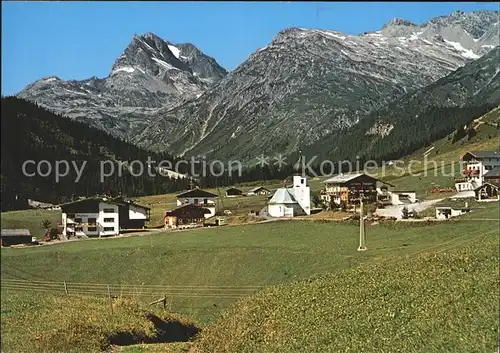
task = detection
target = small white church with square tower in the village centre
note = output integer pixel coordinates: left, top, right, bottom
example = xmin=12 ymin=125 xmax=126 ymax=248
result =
xmin=267 ymin=175 xmax=311 ymax=217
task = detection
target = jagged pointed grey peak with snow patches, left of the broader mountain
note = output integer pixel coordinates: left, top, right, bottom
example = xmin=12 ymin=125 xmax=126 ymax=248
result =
xmin=18 ymin=33 xmax=227 ymax=138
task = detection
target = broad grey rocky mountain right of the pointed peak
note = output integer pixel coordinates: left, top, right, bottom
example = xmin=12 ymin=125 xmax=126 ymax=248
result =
xmin=135 ymin=11 xmax=498 ymax=160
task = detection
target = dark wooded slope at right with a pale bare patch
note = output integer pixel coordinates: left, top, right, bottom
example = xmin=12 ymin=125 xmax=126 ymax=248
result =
xmin=306 ymin=47 xmax=500 ymax=164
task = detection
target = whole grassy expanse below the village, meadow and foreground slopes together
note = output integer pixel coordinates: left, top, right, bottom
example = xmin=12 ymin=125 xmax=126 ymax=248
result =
xmin=1 ymin=203 xmax=498 ymax=353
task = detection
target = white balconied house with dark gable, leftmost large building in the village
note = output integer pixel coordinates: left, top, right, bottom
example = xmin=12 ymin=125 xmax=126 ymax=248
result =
xmin=60 ymin=198 xmax=150 ymax=238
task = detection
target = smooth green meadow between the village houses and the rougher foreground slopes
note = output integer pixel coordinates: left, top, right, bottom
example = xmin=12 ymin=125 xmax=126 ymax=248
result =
xmin=1 ymin=209 xmax=498 ymax=322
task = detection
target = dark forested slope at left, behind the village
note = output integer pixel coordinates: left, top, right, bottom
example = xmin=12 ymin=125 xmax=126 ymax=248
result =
xmin=1 ymin=97 xmax=191 ymax=211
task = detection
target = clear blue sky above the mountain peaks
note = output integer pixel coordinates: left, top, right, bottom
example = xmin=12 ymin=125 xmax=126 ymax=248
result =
xmin=2 ymin=2 xmax=499 ymax=95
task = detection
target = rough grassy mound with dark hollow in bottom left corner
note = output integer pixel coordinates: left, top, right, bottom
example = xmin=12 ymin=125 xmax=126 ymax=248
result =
xmin=2 ymin=293 xmax=199 ymax=353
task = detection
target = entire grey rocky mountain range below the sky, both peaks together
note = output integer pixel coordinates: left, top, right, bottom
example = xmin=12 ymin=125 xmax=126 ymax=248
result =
xmin=19 ymin=11 xmax=499 ymax=161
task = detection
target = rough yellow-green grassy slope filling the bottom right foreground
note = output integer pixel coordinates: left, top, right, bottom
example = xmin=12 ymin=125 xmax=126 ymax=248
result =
xmin=194 ymin=232 xmax=499 ymax=353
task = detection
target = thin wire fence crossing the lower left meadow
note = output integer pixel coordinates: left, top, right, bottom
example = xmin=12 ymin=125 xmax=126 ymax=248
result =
xmin=1 ymin=279 xmax=263 ymax=299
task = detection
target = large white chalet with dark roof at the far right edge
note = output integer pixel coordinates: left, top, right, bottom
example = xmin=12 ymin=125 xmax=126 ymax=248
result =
xmin=455 ymin=151 xmax=500 ymax=192
